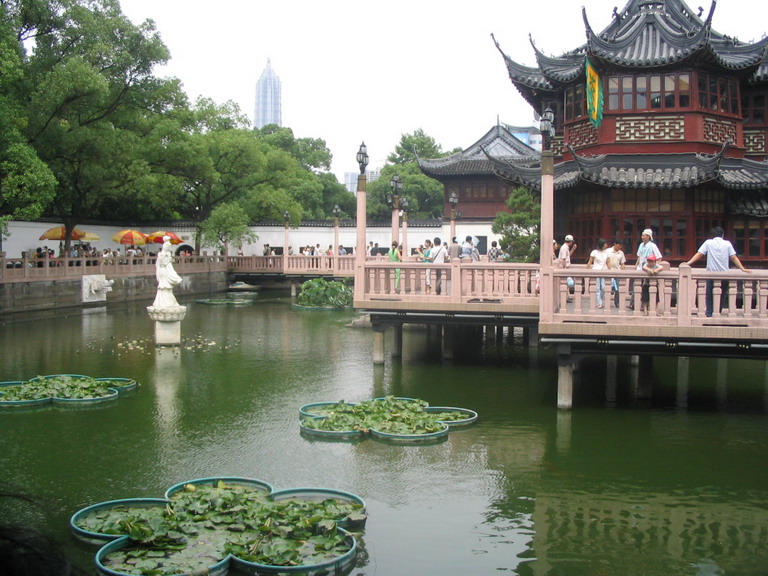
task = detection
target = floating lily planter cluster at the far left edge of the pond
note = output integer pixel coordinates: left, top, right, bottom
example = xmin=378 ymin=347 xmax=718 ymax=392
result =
xmin=0 ymin=374 xmax=138 ymax=407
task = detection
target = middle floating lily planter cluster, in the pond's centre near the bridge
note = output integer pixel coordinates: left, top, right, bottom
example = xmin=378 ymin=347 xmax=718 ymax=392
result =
xmin=299 ymin=396 xmax=477 ymax=443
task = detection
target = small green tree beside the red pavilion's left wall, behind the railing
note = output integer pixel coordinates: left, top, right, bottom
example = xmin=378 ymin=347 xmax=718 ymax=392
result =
xmin=491 ymin=187 xmax=541 ymax=262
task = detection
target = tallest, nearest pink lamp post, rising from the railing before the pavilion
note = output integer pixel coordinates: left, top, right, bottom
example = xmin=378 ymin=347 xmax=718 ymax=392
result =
xmin=539 ymin=106 xmax=555 ymax=321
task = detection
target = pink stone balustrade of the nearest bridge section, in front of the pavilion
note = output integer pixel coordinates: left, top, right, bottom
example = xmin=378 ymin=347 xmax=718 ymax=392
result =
xmin=355 ymin=260 xmax=768 ymax=327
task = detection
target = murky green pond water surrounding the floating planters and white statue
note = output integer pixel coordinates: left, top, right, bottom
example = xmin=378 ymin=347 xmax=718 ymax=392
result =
xmin=0 ymin=294 xmax=768 ymax=576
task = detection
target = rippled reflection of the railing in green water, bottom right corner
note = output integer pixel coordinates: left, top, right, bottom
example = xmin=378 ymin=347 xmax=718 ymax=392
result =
xmin=530 ymin=490 xmax=768 ymax=575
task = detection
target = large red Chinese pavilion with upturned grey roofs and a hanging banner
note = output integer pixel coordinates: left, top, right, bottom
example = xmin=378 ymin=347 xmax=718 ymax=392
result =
xmin=428 ymin=0 xmax=768 ymax=265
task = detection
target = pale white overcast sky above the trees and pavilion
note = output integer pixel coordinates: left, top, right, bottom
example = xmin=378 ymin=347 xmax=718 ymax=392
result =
xmin=120 ymin=0 xmax=768 ymax=182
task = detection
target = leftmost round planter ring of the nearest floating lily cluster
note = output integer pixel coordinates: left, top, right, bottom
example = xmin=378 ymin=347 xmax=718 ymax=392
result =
xmin=69 ymin=498 xmax=168 ymax=545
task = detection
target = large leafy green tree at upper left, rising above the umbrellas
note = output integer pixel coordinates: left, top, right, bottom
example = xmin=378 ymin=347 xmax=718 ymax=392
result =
xmin=14 ymin=0 xmax=179 ymax=248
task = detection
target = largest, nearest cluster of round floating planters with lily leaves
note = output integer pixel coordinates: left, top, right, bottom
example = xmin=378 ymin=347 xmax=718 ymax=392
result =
xmin=70 ymin=477 xmax=366 ymax=576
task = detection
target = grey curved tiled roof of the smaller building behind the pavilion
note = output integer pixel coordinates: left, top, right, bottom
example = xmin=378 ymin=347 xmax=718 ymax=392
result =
xmin=418 ymin=124 xmax=538 ymax=177
